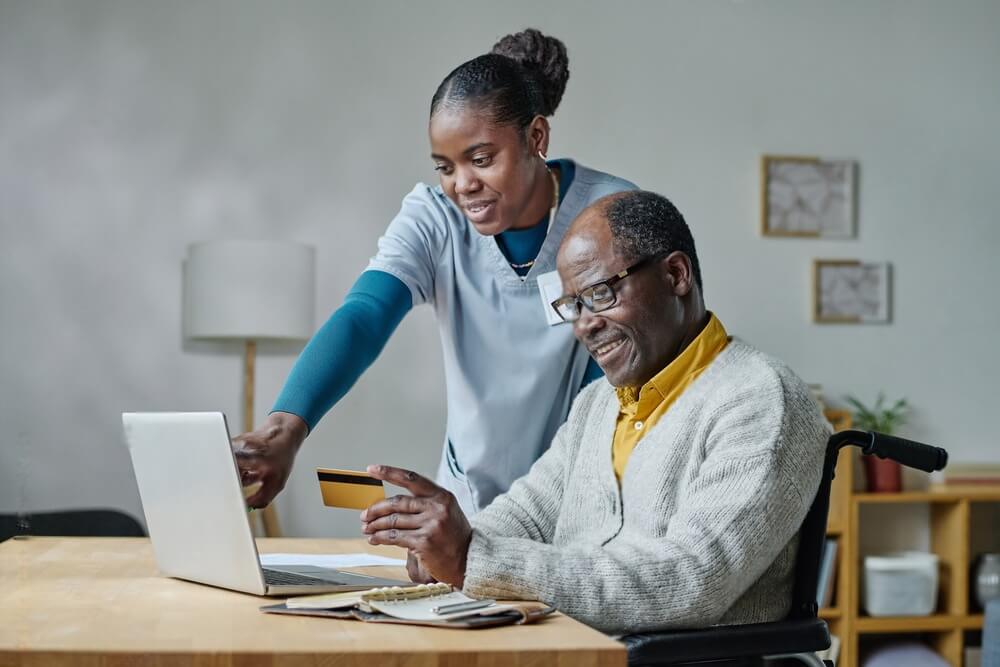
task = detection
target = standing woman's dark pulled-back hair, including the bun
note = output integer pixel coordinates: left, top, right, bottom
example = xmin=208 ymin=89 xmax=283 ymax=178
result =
xmin=431 ymin=28 xmax=569 ymax=130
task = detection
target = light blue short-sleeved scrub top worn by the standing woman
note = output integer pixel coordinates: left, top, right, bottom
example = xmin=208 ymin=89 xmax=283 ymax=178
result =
xmin=368 ymin=164 xmax=635 ymax=516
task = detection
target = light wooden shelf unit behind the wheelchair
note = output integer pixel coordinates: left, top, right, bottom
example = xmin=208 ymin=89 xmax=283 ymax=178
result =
xmin=820 ymin=410 xmax=1000 ymax=667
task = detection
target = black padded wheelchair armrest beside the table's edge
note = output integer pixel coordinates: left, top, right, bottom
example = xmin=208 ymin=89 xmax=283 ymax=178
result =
xmin=620 ymin=618 xmax=830 ymax=666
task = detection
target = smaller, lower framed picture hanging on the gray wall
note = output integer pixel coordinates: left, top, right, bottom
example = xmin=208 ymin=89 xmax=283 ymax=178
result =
xmin=813 ymin=259 xmax=890 ymax=324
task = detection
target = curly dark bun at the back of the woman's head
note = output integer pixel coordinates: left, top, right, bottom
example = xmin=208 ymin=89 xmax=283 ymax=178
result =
xmin=492 ymin=28 xmax=569 ymax=116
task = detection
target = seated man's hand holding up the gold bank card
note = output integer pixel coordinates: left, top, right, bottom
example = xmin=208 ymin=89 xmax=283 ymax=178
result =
xmin=361 ymin=465 xmax=472 ymax=588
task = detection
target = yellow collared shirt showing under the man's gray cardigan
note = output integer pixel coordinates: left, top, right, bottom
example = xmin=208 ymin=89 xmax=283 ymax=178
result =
xmin=611 ymin=313 xmax=729 ymax=484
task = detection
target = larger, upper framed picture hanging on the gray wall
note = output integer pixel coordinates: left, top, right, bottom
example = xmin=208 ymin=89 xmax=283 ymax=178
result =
xmin=761 ymin=155 xmax=857 ymax=239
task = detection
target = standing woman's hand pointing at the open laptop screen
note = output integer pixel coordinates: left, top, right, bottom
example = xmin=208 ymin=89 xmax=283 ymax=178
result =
xmin=232 ymin=412 xmax=309 ymax=508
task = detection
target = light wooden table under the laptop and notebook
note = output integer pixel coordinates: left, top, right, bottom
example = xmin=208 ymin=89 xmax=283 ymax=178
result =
xmin=0 ymin=537 xmax=626 ymax=667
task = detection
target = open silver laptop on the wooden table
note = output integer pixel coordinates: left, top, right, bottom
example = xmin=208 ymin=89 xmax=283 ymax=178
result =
xmin=122 ymin=412 xmax=408 ymax=595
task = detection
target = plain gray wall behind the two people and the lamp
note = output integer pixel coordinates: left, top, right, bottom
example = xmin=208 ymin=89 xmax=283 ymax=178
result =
xmin=0 ymin=0 xmax=1000 ymax=535
